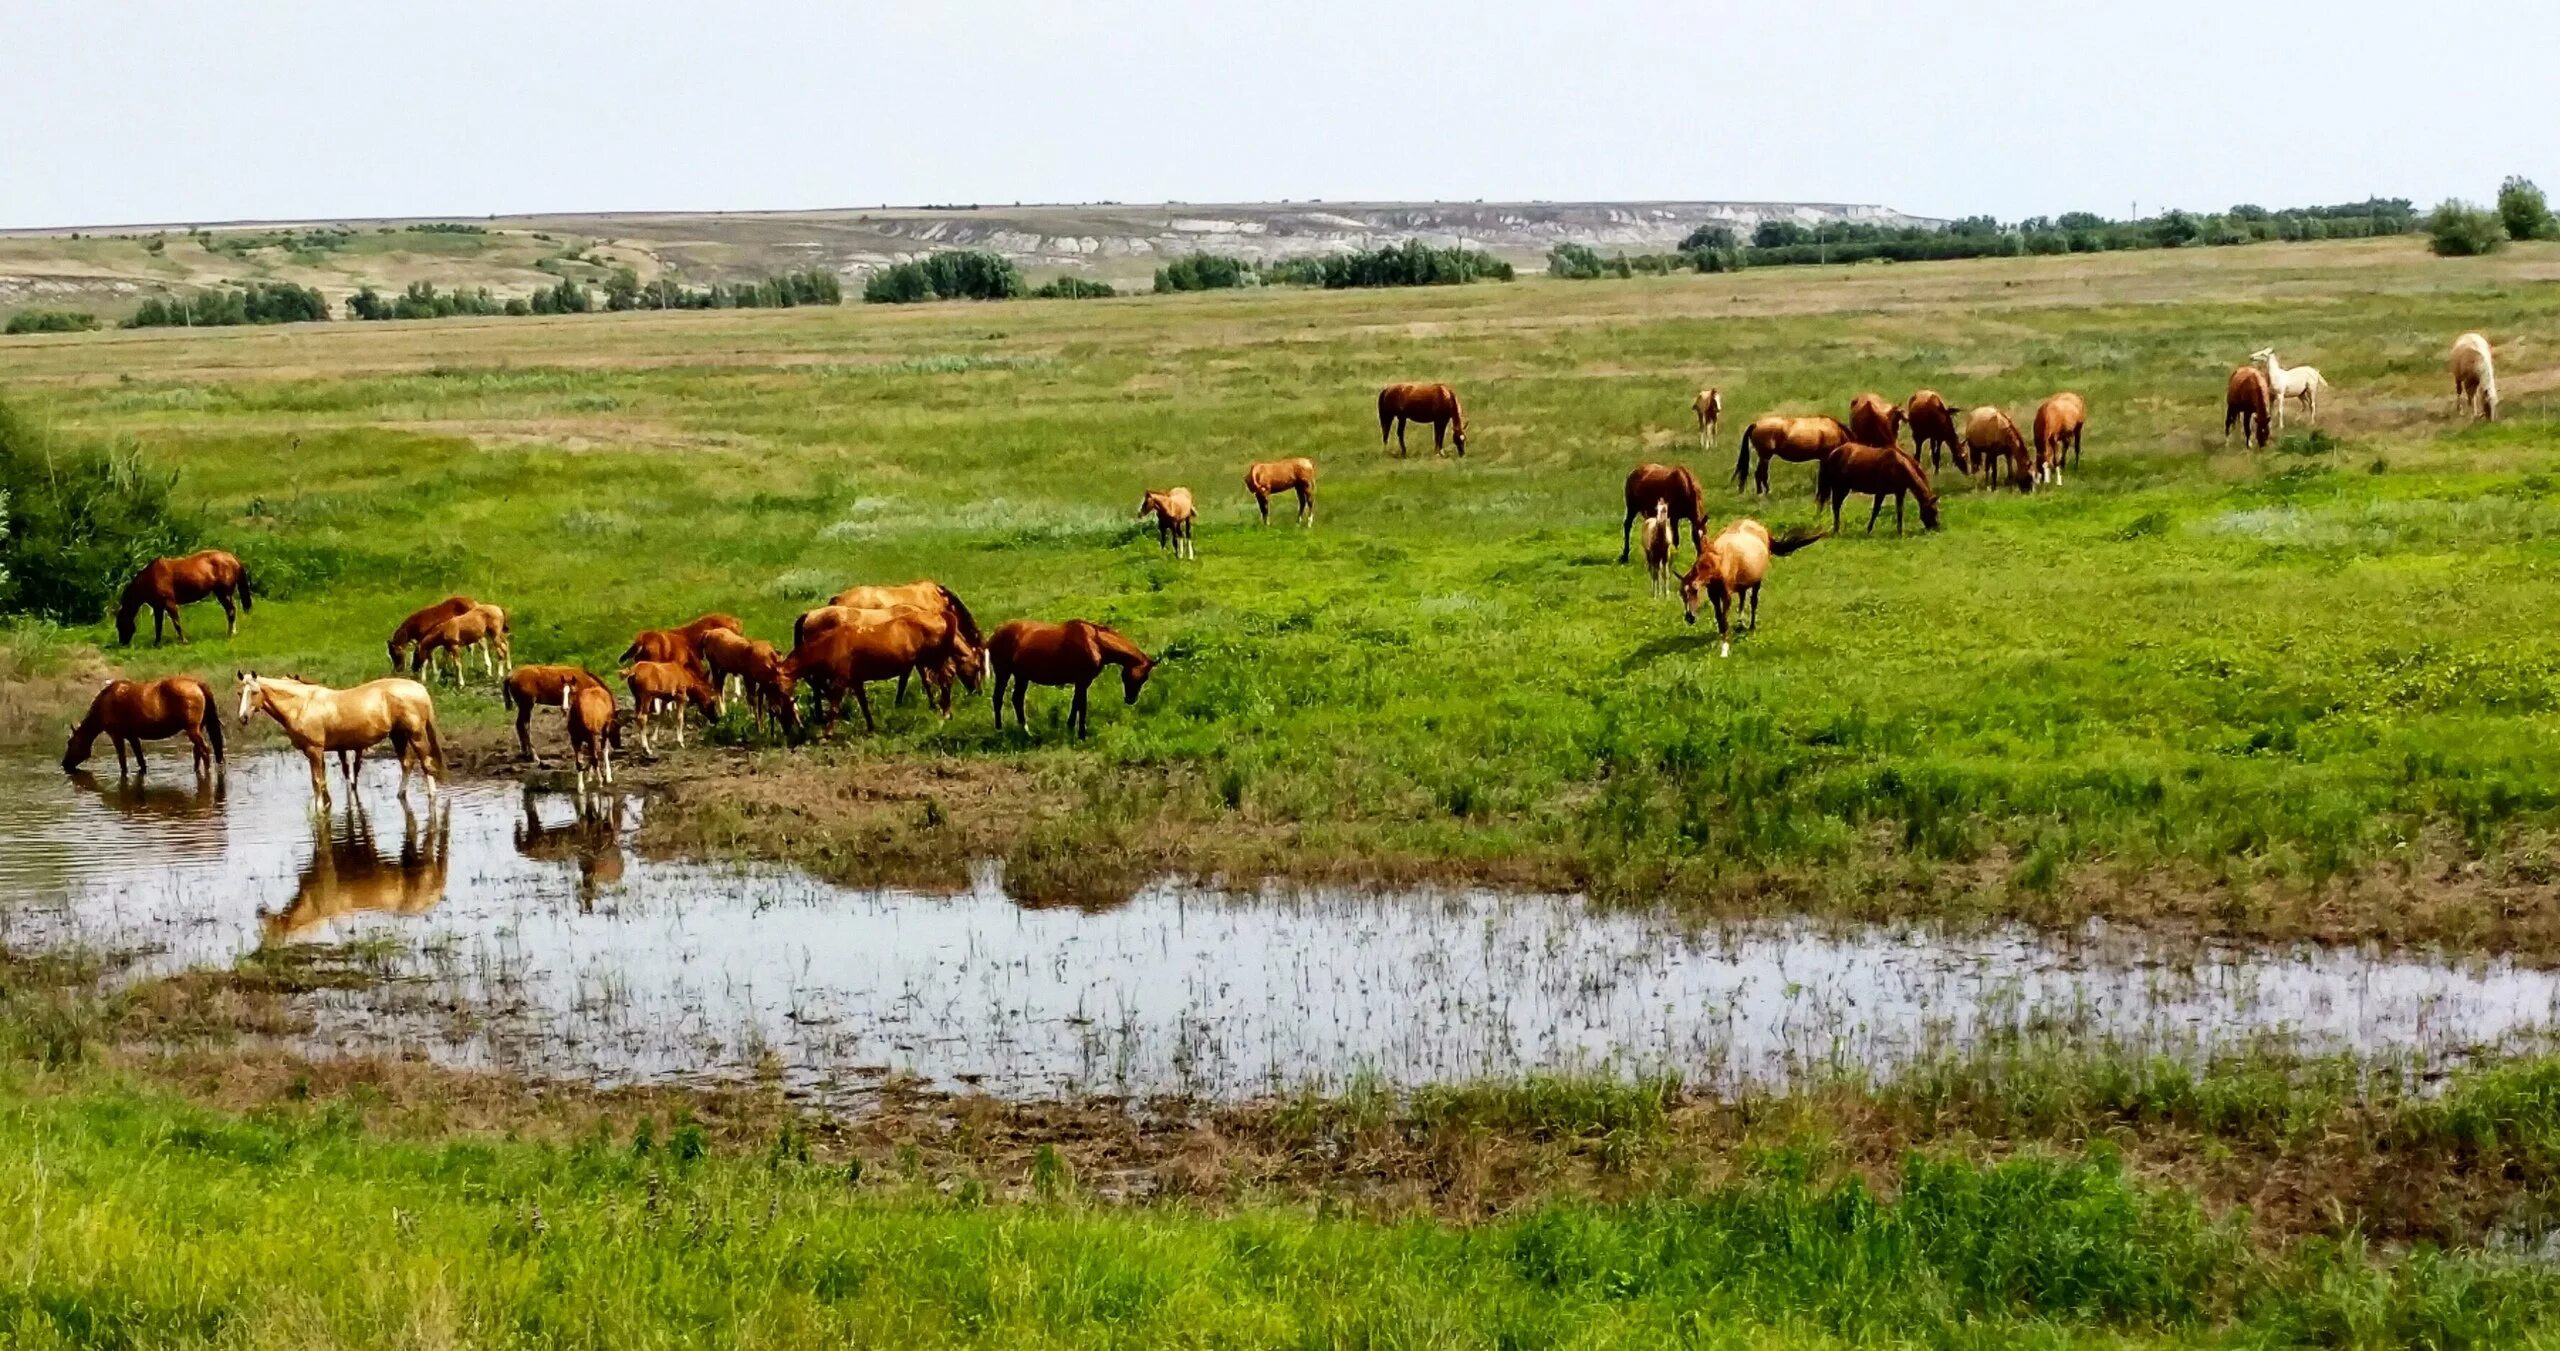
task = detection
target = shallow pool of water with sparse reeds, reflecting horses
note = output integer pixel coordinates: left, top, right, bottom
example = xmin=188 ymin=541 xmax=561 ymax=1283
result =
xmin=0 ymin=757 xmax=2560 ymax=1098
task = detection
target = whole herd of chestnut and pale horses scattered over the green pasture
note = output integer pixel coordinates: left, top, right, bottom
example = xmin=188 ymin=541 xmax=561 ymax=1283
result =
xmin=61 ymin=333 xmax=2499 ymax=809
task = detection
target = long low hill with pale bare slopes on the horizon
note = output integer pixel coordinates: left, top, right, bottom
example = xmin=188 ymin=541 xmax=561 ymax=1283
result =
xmin=0 ymin=202 xmax=1935 ymax=315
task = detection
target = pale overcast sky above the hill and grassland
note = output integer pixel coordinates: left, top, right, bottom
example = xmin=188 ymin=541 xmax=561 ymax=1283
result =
xmin=0 ymin=0 xmax=2560 ymax=228
